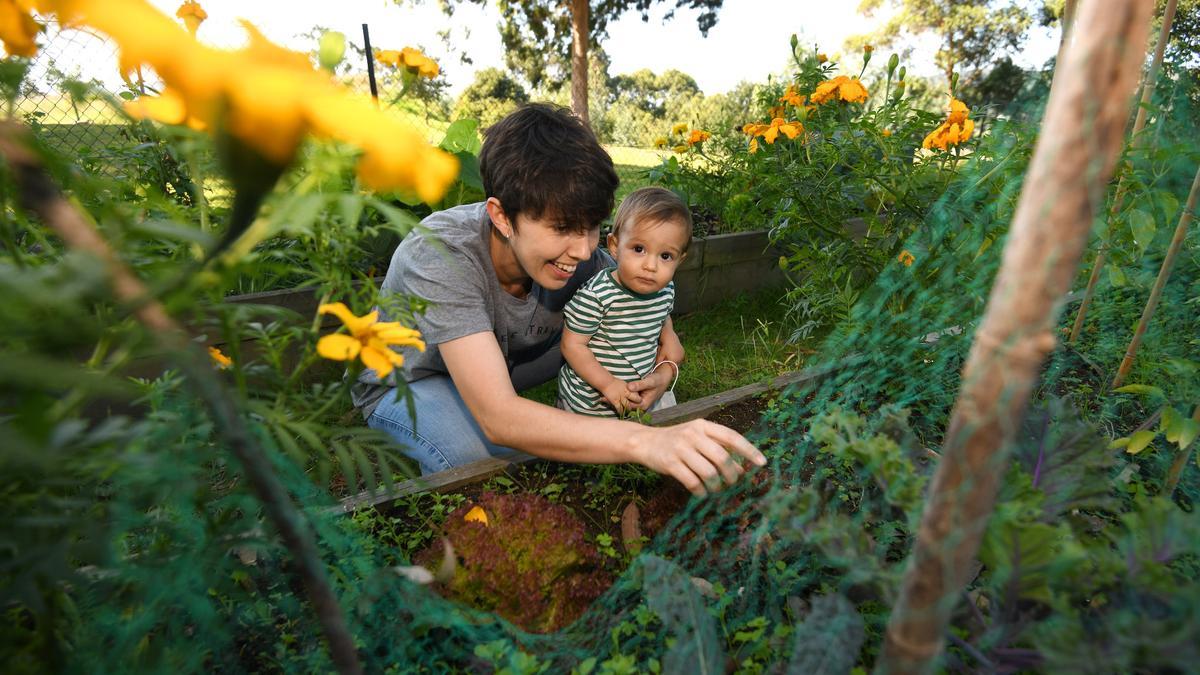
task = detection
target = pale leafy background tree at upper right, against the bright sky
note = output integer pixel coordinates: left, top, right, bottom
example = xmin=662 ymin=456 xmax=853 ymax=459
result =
xmin=853 ymin=0 xmax=1040 ymax=83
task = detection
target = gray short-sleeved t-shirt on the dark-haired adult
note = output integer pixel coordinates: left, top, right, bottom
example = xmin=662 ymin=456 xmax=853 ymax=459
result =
xmin=350 ymin=203 xmax=613 ymax=417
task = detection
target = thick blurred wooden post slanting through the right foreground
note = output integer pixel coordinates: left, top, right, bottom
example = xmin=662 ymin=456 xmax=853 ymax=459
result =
xmin=876 ymin=0 xmax=1153 ymax=674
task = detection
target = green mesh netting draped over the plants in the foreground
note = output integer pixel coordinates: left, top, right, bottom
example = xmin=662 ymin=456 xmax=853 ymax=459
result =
xmin=0 ymin=34 xmax=1200 ymax=673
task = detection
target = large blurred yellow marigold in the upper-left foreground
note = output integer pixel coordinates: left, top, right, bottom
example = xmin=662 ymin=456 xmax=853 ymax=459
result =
xmin=65 ymin=0 xmax=457 ymax=202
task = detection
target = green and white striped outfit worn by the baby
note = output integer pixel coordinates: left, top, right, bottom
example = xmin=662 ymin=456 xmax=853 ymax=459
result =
xmin=558 ymin=268 xmax=674 ymax=417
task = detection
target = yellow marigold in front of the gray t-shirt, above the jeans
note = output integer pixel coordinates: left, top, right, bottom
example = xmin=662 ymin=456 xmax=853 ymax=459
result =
xmin=317 ymin=303 xmax=425 ymax=377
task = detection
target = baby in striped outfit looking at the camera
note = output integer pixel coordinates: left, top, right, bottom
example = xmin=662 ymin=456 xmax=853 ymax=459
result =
xmin=558 ymin=187 xmax=691 ymax=417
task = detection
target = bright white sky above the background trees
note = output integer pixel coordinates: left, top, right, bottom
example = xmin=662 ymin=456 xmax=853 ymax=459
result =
xmin=126 ymin=0 xmax=1057 ymax=96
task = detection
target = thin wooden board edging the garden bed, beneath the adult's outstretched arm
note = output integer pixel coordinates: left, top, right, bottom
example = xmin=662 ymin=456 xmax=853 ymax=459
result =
xmin=330 ymin=359 xmax=851 ymax=514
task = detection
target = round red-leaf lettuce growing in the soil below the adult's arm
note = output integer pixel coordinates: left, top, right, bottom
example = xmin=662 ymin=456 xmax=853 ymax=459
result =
xmin=416 ymin=492 xmax=612 ymax=633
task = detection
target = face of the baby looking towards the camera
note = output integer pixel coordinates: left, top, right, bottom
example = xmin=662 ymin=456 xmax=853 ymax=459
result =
xmin=608 ymin=220 xmax=690 ymax=293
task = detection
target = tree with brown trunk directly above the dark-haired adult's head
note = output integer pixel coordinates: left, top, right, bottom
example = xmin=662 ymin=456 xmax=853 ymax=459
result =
xmin=429 ymin=0 xmax=724 ymax=121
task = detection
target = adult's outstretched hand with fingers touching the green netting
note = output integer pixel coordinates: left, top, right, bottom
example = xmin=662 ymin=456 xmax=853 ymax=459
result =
xmin=629 ymin=419 xmax=767 ymax=496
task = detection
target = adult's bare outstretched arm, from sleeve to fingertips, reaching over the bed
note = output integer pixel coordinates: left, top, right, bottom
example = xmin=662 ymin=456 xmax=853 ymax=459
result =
xmin=438 ymin=333 xmax=767 ymax=495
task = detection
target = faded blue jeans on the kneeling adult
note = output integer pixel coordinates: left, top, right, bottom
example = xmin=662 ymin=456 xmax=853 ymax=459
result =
xmin=367 ymin=375 xmax=526 ymax=476
